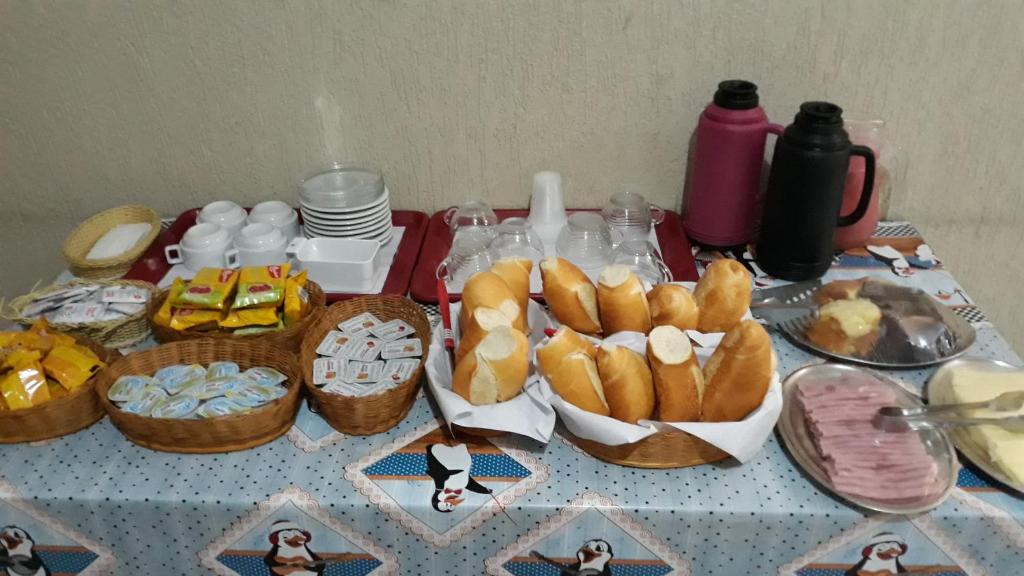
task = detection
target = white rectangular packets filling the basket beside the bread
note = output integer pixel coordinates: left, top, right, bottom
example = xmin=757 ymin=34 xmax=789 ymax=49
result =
xmin=313 ymin=312 xmax=423 ymax=397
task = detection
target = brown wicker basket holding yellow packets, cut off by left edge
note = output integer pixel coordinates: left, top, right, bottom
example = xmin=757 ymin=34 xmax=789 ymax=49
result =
xmin=0 ymin=336 xmax=121 ymax=444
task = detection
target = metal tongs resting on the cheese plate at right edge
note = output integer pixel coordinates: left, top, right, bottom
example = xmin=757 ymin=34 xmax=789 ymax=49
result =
xmin=873 ymin=392 xmax=1024 ymax=433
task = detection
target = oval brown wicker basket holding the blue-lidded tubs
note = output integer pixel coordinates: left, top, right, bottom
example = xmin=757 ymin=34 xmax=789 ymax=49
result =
xmin=96 ymin=339 xmax=302 ymax=454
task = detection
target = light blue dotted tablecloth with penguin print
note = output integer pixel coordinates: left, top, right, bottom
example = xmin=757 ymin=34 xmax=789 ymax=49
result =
xmin=0 ymin=222 xmax=1024 ymax=576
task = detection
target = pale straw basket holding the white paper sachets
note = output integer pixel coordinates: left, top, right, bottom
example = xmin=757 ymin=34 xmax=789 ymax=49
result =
xmin=4 ymin=280 xmax=157 ymax=348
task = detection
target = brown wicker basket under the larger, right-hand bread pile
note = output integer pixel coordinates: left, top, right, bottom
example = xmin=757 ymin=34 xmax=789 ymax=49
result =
xmin=565 ymin=429 xmax=729 ymax=468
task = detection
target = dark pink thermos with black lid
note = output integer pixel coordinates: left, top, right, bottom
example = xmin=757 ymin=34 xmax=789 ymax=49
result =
xmin=684 ymin=80 xmax=783 ymax=247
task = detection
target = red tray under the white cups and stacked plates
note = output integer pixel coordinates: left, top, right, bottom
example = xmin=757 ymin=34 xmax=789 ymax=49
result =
xmin=124 ymin=208 xmax=428 ymax=303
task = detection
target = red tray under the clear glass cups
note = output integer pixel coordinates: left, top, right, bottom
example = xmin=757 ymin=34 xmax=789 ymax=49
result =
xmin=409 ymin=210 xmax=697 ymax=303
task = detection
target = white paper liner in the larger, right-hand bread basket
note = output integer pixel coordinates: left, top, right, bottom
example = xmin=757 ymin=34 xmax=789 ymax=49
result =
xmin=534 ymin=332 xmax=782 ymax=462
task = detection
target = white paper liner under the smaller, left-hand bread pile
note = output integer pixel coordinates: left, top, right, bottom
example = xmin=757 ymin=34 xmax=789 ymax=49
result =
xmin=426 ymin=300 xmax=555 ymax=443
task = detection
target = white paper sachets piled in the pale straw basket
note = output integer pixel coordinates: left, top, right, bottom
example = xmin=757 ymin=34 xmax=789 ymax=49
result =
xmin=22 ymin=284 xmax=150 ymax=324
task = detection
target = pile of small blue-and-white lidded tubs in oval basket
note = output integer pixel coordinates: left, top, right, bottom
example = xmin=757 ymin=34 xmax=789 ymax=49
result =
xmin=106 ymin=362 xmax=288 ymax=418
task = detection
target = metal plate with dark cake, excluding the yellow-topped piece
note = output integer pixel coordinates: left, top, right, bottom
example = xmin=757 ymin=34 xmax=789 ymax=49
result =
xmin=778 ymin=281 xmax=975 ymax=368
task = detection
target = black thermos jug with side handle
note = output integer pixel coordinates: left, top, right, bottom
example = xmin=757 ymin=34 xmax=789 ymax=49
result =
xmin=757 ymin=102 xmax=874 ymax=282
